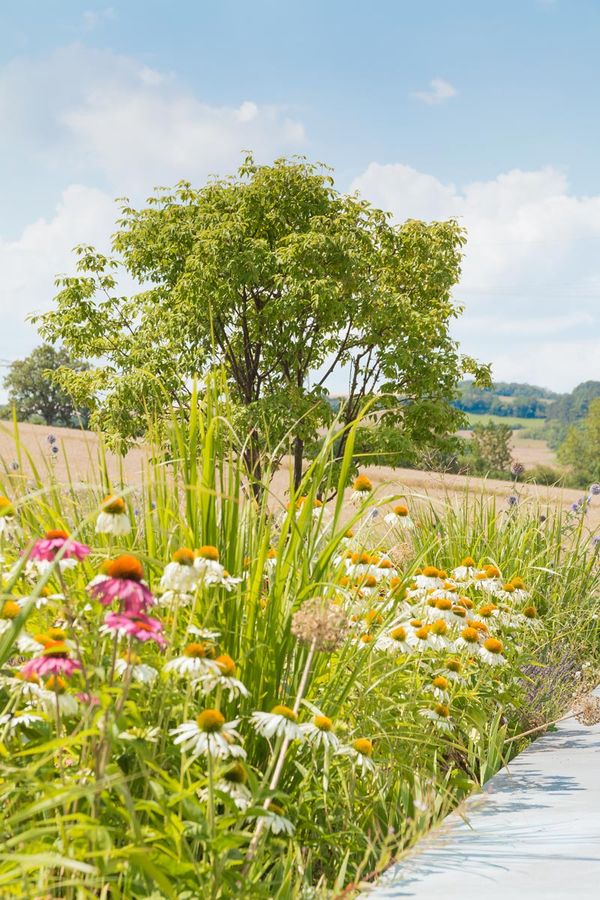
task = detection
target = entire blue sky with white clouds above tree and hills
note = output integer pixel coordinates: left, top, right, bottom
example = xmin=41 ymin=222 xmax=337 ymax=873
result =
xmin=0 ymin=0 xmax=600 ymax=391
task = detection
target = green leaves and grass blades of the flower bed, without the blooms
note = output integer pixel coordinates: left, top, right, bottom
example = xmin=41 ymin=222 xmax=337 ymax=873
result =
xmin=0 ymin=396 xmax=599 ymax=900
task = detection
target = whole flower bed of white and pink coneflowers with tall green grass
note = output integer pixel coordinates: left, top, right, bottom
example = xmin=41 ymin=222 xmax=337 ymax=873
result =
xmin=0 ymin=391 xmax=599 ymax=900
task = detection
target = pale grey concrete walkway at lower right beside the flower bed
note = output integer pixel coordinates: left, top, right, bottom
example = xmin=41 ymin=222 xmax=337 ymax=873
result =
xmin=364 ymin=688 xmax=600 ymax=900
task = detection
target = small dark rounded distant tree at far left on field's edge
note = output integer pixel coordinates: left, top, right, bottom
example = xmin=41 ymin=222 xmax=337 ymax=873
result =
xmin=4 ymin=344 xmax=89 ymax=428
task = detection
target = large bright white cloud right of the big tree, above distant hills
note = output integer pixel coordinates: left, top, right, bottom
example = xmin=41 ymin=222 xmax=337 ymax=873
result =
xmin=352 ymin=163 xmax=600 ymax=390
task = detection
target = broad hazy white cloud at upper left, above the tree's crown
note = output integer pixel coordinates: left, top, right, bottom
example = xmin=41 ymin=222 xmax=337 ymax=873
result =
xmin=0 ymin=45 xmax=306 ymax=196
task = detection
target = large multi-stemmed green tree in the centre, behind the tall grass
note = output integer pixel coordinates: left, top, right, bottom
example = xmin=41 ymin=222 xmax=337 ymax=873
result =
xmin=34 ymin=156 xmax=488 ymax=483
